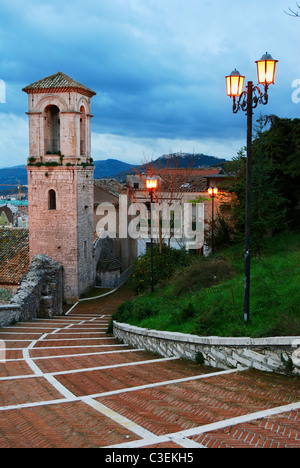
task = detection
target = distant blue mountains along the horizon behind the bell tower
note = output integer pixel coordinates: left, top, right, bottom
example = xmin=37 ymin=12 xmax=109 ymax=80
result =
xmin=0 ymin=153 xmax=226 ymax=192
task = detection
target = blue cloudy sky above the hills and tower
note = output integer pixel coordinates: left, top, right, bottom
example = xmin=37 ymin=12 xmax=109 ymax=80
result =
xmin=0 ymin=0 xmax=300 ymax=167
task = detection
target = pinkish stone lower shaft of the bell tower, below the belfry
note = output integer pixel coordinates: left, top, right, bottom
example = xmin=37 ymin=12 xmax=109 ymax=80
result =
xmin=27 ymin=166 xmax=94 ymax=302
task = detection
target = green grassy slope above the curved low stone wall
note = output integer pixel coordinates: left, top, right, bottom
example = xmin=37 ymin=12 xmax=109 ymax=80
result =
xmin=113 ymin=232 xmax=300 ymax=337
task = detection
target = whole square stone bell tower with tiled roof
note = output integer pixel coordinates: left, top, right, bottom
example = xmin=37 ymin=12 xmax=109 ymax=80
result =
xmin=23 ymin=72 xmax=96 ymax=302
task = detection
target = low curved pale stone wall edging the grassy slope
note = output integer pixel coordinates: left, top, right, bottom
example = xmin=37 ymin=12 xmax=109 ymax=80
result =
xmin=113 ymin=322 xmax=300 ymax=375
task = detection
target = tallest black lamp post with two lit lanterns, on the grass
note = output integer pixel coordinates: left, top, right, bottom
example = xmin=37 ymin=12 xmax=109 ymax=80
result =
xmin=226 ymin=53 xmax=278 ymax=322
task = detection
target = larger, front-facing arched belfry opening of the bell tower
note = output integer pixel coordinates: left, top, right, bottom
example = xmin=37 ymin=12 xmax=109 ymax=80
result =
xmin=44 ymin=105 xmax=60 ymax=154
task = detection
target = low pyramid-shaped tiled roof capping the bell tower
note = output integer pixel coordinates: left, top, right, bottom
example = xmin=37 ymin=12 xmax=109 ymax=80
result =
xmin=22 ymin=72 xmax=96 ymax=97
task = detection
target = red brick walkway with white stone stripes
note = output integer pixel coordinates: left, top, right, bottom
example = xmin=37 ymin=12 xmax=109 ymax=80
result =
xmin=0 ymin=296 xmax=300 ymax=449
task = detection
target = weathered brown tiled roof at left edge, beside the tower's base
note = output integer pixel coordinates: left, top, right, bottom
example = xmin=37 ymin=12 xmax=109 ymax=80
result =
xmin=0 ymin=228 xmax=29 ymax=284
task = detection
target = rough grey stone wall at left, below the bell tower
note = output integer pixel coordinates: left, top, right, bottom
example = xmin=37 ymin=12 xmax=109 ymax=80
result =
xmin=0 ymin=255 xmax=63 ymax=327
